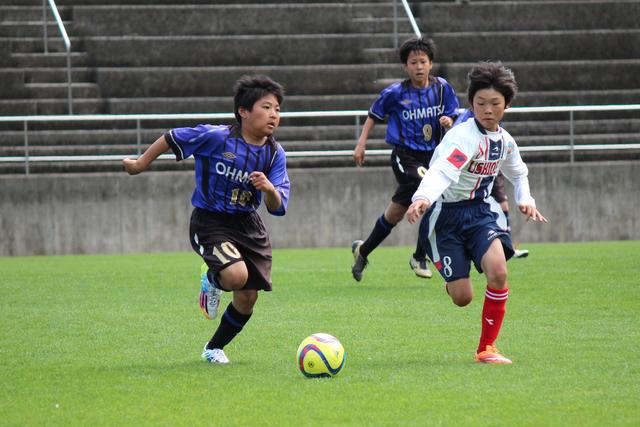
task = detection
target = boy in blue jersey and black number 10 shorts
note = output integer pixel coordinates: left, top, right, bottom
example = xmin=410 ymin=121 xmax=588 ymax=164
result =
xmin=123 ymin=76 xmax=290 ymax=364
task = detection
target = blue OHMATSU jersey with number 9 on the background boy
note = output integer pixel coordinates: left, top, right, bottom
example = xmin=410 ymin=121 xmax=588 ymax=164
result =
xmin=369 ymin=77 xmax=459 ymax=151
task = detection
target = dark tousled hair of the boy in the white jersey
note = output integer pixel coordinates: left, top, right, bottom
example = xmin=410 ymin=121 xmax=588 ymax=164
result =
xmin=467 ymin=61 xmax=518 ymax=105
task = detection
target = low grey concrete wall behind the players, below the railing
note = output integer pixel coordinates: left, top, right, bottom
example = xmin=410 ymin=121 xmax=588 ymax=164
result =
xmin=0 ymin=161 xmax=640 ymax=256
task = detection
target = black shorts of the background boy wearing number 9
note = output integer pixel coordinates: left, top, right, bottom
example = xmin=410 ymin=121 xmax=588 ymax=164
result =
xmin=391 ymin=146 xmax=433 ymax=207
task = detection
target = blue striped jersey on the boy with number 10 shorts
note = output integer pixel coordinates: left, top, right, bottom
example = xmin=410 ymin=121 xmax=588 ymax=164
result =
xmin=165 ymin=125 xmax=290 ymax=215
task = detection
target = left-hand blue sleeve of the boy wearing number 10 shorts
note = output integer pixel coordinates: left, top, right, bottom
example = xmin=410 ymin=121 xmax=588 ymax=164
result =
xmin=165 ymin=125 xmax=228 ymax=161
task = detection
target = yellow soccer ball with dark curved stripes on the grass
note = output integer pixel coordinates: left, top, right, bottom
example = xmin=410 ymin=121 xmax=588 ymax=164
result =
xmin=298 ymin=333 xmax=347 ymax=378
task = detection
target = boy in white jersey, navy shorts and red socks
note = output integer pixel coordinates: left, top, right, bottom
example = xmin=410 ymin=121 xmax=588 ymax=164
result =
xmin=407 ymin=62 xmax=547 ymax=363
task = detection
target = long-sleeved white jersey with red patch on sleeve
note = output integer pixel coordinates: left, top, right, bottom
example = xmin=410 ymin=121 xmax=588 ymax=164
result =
xmin=412 ymin=120 xmax=535 ymax=206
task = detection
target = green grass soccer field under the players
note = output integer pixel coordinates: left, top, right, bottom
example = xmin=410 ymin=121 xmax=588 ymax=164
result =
xmin=0 ymin=241 xmax=640 ymax=426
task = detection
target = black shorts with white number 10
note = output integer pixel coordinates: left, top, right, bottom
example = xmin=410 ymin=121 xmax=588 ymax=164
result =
xmin=189 ymin=208 xmax=272 ymax=291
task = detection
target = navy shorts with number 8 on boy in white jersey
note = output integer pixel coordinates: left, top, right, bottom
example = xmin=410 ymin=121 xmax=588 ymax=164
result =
xmin=419 ymin=199 xmax=514 ymax=282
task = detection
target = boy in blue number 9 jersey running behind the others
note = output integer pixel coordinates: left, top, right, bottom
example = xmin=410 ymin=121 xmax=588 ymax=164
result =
xmin=351 ymin=38 xmax=458 ymax=281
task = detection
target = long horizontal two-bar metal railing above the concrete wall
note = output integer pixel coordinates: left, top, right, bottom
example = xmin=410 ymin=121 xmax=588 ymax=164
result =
xmin=0 ymin=104 xmax=640 ymax=175
